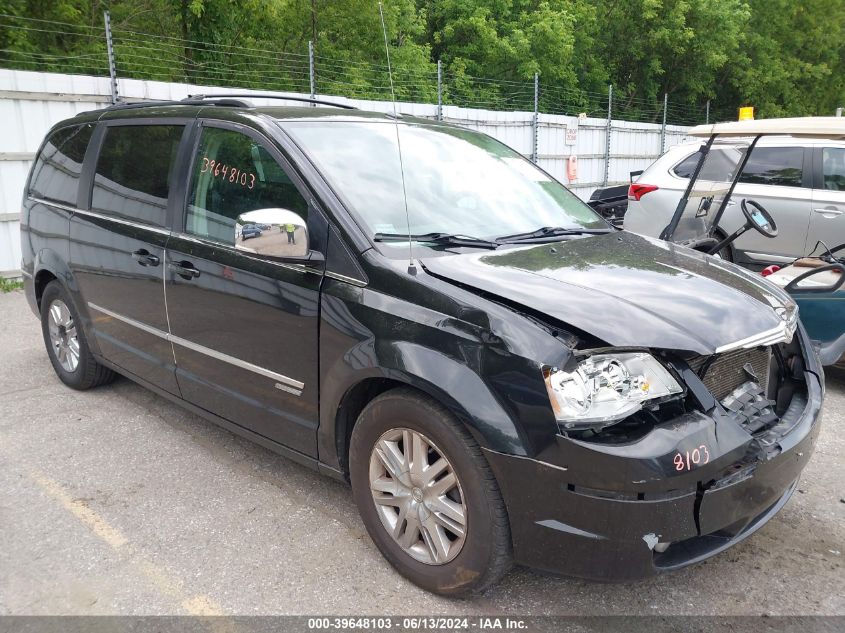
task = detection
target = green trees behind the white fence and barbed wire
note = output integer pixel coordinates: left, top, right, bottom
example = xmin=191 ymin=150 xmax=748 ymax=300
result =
xmin=0 ymin=0 xmax=845 ymax=123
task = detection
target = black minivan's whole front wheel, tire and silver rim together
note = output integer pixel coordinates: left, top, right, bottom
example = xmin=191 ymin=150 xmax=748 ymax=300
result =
xmin=349 ymin=388 xmax=511 ymax=596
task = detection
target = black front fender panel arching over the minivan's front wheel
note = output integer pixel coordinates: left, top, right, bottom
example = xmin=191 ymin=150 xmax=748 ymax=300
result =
xmin=317 ymin=286 xmax=556 ymax=468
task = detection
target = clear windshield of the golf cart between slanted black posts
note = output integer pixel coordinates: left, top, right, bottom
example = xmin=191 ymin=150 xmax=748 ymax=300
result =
xmin=669 ymin=139 xmax=749 ymax=242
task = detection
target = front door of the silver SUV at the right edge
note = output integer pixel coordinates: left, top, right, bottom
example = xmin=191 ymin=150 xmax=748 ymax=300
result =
xmin=807 ymin=147 xmax=845 ymax=255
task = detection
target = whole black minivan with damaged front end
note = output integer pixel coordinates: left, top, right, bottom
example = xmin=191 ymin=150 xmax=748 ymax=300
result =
xmin=21 ymin=97 xmax=824 ymax=595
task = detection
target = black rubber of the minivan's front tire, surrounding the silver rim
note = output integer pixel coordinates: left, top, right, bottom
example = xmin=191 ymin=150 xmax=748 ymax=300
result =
xmin=349 ymin=394 xmax=498 ymax=596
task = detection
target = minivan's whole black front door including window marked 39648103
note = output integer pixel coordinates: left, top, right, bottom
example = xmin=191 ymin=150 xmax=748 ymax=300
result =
xmin=166 ymin=123 xmax=327 ymax=456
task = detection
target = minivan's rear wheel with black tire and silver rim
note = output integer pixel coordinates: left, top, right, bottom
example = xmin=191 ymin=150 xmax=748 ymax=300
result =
xmin=41 ymin=280 xmax=115 ymax=390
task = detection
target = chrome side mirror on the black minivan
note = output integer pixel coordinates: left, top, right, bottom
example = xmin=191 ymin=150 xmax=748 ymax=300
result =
xmin=235 ymin=208 xmax=310 ymax=259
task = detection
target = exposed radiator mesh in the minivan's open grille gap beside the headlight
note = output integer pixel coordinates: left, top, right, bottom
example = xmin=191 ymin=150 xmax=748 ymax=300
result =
xmin=689 ymin=347 xmax=772 ymax=401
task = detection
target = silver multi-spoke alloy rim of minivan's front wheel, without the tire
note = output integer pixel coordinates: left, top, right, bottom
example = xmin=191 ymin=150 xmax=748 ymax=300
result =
xmin=369 ymin=428 xmax=467 ymax=565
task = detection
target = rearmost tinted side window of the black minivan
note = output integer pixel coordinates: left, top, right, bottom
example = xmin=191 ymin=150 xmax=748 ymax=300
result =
xmin=29 ymin=124 xmax=94 ymax=206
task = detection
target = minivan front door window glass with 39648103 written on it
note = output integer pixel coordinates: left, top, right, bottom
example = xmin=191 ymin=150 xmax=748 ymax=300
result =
xmin=185 ymin=127 xmax=308 ymax=246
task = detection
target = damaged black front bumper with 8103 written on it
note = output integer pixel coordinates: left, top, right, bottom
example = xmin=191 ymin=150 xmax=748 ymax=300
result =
xmin=485 ymin=329 xmax=823 ymax=580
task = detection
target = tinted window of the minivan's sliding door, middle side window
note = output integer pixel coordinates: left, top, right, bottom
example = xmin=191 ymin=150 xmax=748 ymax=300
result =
xmin=91 ymin=125 xmax=184 ymax=226
